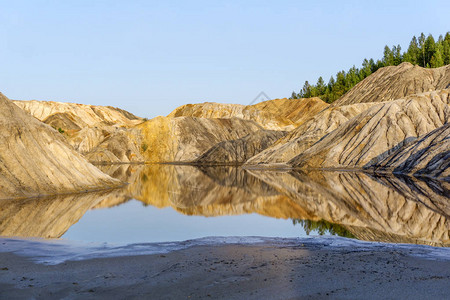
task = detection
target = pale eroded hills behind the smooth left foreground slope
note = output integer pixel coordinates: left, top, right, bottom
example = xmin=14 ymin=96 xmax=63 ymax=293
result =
xmin=14 ymin=100 xmax=143 ymax=163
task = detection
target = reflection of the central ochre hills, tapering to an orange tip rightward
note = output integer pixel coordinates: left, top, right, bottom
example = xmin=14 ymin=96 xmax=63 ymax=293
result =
xmin=96 ymin=165 xmax=313 ymax=219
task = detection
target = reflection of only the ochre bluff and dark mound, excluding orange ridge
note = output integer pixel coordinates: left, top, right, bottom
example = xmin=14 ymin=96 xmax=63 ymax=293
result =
xmin=135 ymin=166 xmax=290 ymax=216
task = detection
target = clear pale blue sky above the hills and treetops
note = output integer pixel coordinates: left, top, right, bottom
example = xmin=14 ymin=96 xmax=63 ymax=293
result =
xmin=0 ymin=0 xmax=450 ymax=117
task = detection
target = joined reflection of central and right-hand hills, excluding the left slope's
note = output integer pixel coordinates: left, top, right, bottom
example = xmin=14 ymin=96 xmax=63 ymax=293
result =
xmin=97 ymin=165 xmax=450 ymax=246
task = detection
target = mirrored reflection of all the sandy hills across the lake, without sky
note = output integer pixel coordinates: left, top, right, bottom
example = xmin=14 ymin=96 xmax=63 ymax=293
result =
xmin=0 ymin=165 xmax=450 ymax=246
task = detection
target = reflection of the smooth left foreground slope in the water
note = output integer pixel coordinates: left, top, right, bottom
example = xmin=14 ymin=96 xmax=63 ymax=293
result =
xmin=0 ymin=190 xmax=118 ymax=238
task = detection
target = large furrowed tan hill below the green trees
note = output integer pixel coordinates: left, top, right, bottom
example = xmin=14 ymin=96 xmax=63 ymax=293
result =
xmin=245 ymin=63 xmax=450 ymax=177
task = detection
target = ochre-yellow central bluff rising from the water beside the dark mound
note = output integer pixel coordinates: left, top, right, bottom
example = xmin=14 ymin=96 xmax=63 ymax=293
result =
xmin=136 ymin=117 xmax=262 ymax=163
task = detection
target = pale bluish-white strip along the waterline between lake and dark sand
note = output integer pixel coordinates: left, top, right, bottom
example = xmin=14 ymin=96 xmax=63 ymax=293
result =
xmin=0 ymin=235 xmax=450 ymax=265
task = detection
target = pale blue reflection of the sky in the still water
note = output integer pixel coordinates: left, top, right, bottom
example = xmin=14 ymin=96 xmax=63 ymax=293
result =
xmin=63 ymin=200 xmax=316 ymax=244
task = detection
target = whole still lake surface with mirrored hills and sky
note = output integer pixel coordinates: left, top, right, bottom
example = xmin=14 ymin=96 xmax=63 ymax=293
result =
xmin=0 ymin=165 xmax=450 ymax=246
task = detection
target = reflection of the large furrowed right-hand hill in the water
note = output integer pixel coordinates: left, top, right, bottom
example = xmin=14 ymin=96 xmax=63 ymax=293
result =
xmin=252 ymin=171 xmax=450 ymax=245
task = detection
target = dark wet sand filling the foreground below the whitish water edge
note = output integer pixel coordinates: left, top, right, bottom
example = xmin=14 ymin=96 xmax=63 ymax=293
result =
xmin=0 ymin=244 xmax=450 ymax=299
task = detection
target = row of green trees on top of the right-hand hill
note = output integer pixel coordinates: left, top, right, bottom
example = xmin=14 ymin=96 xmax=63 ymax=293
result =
xmin=290 ymin=32 xmax=450 ymax=103
